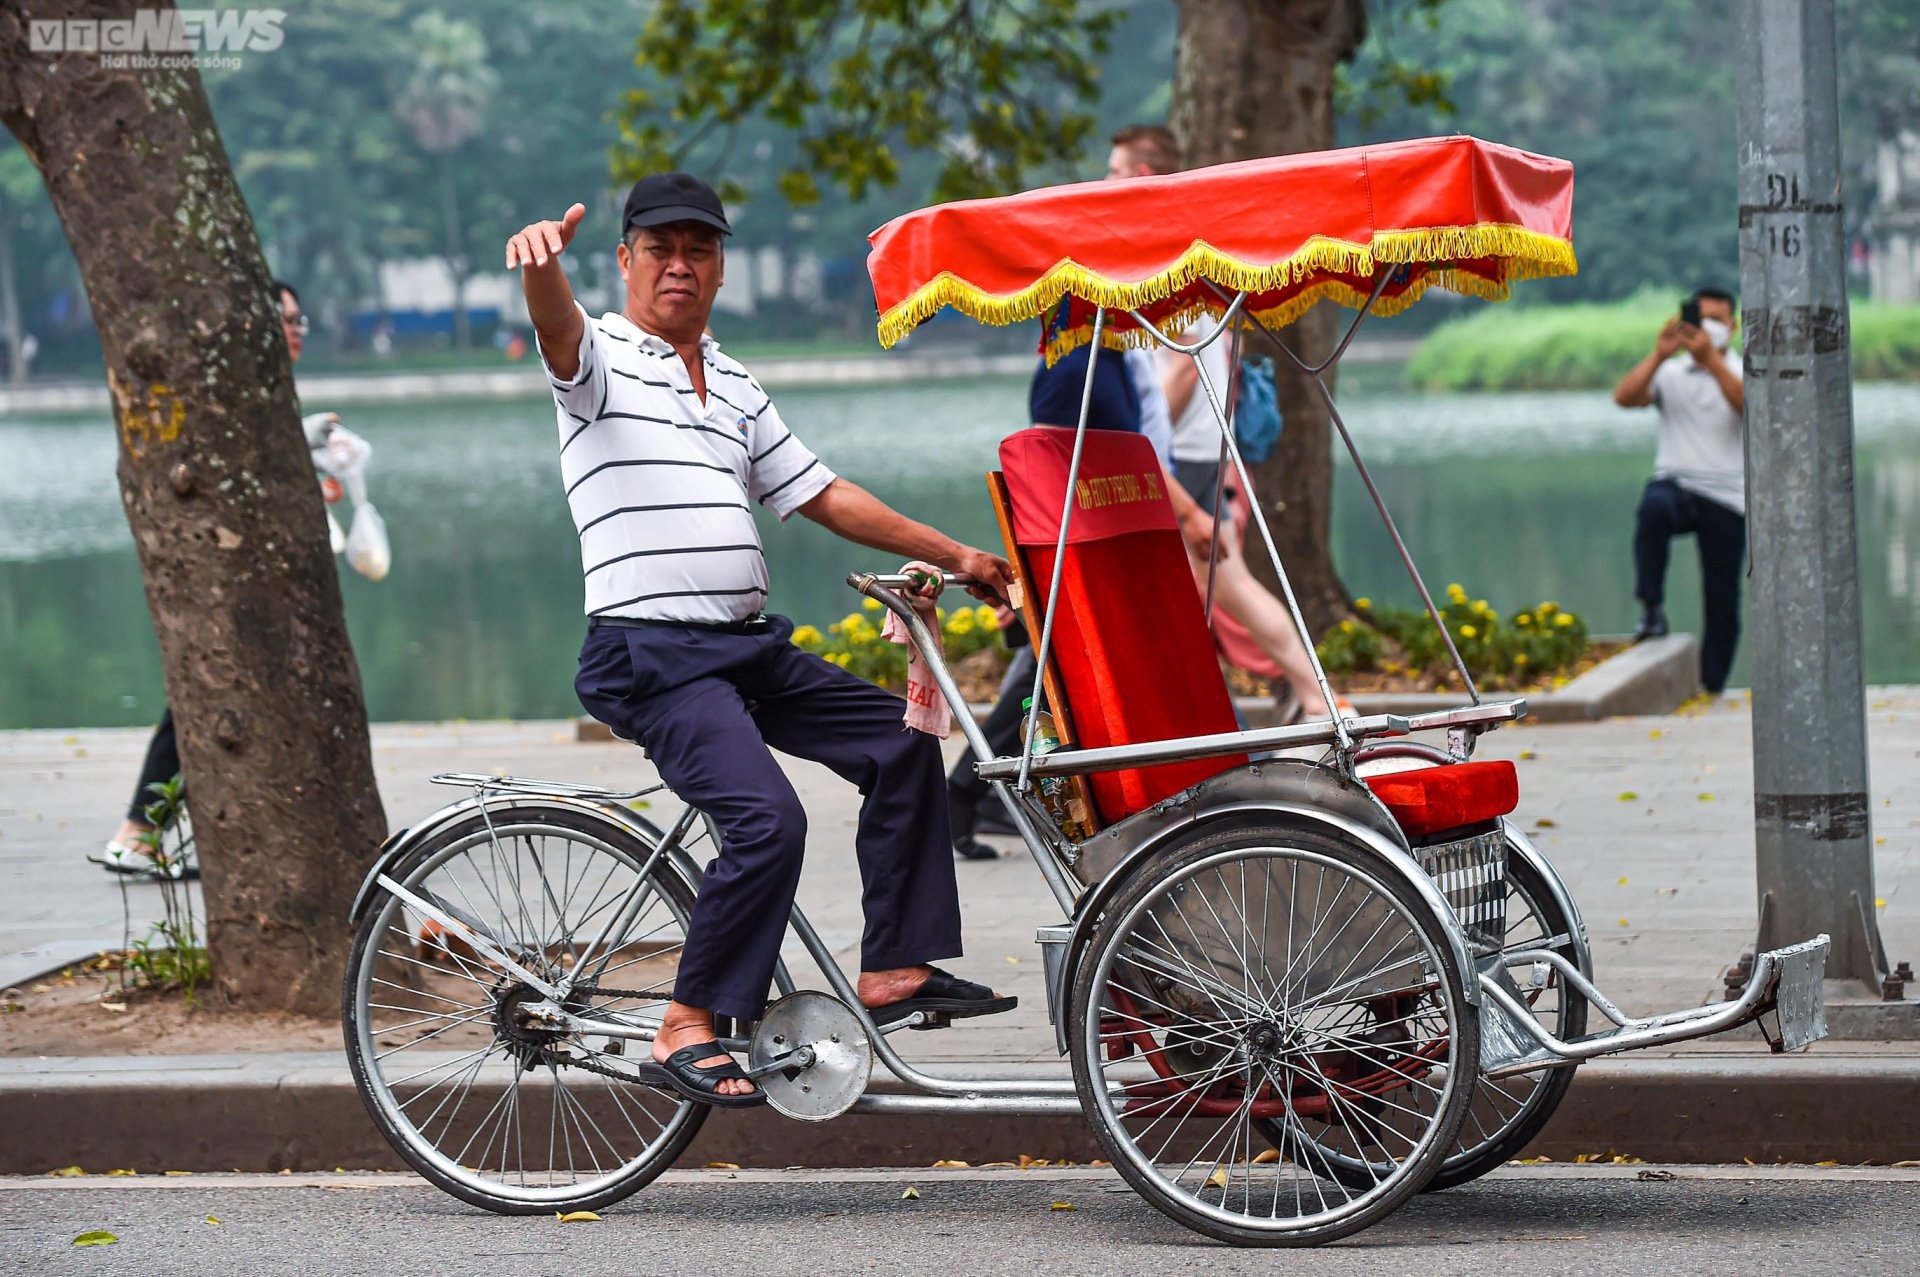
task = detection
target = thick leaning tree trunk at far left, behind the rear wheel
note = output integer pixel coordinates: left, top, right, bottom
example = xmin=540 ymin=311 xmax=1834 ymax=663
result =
xmin=0 ymin=0 xmax=386 ymax=1014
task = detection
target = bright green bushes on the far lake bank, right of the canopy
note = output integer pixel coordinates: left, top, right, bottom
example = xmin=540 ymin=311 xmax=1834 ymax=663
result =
xmin=1407 ymin=290 xmax=1920 ymax=390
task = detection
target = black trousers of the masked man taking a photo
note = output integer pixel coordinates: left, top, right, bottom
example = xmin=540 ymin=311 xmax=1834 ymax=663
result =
xmin=1634 ymin=478 xmax=1747 ymax=691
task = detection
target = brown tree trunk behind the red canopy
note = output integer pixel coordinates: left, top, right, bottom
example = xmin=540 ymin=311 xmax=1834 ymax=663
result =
xmin=1171 ymin=0 xmax=1367 ymax=634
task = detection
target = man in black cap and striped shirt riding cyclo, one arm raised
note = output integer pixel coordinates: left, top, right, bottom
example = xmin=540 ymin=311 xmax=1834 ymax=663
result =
xmin=507 ymin=173 xmax=1016 ymax=1108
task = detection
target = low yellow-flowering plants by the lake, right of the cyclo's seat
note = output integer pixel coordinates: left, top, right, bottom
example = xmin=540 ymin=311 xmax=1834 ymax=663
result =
xmin=1317 ymin=584 xmax=1588 ymax=687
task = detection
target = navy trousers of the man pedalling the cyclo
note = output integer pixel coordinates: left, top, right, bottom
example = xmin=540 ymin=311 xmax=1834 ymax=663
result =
xmin=574 ymin=616 xmax=960 ymax=1020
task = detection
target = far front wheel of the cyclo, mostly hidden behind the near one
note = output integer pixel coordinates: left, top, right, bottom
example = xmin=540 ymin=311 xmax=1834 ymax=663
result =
xmin=1260 ymin=841 xmax=1586 ymax=1193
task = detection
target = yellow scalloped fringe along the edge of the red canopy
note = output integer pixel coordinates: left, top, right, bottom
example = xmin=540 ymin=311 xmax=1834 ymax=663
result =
xmin=879 ymin=223 xmax=1580 ymax=361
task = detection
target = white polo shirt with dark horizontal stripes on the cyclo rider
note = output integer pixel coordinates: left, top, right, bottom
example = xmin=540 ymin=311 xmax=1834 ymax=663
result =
xmin=547 ymin=303 xmax=833 ymax=622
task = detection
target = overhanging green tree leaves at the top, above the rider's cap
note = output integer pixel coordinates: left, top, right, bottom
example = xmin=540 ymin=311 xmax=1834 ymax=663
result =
xmin=614 ymin=0 xmax=1119 ymax=205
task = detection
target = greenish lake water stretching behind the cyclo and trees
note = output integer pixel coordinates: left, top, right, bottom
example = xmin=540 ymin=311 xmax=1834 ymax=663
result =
xmin=0 ymin=378 xmax=1920 ymax=728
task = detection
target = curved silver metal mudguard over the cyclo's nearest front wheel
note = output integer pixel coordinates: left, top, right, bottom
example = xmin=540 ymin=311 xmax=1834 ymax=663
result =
xmin=1046 ymin=759 xmax=1474 ymax=1054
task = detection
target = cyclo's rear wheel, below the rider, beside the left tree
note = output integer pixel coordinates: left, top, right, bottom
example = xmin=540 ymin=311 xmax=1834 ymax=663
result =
xmin=342 ymin=803 xmax=710 ymax=1214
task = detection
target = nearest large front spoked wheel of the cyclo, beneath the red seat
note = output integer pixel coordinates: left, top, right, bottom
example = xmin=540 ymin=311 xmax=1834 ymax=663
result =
xmin=1069 ymin=822 xmax=1478 ymax=1246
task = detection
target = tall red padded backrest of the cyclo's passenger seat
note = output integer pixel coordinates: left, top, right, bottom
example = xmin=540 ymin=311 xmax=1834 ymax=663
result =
xmin=1000 ymin=426 xmax=1246 ymax=822
